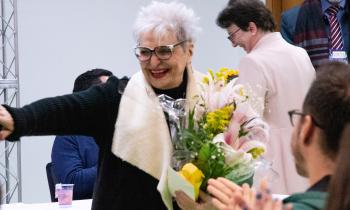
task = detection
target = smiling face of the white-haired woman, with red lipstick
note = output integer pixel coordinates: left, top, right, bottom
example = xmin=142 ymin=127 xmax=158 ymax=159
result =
xmin=139 ymin=32 xmax=193 ymax=90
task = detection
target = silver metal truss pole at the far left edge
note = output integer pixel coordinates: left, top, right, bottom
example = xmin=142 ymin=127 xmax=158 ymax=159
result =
xmin=0 ymin=0 xmax=22 ymax=203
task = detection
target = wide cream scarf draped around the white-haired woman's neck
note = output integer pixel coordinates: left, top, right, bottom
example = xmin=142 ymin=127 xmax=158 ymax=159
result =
xmin=112 ymin=66 xmax=202 ymax=209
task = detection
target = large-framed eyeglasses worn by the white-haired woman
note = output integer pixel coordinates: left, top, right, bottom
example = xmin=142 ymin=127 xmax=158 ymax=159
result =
xmin=135 ymin=40 xmax=187 ymax=62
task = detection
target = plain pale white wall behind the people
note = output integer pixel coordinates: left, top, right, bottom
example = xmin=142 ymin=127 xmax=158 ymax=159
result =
xmin=18 ymin=0 xmax=244 ymax=203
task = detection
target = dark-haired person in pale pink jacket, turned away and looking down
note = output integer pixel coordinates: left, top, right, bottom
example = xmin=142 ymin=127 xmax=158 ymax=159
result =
xmin=217 ymin=0 xmax=315 ymax=194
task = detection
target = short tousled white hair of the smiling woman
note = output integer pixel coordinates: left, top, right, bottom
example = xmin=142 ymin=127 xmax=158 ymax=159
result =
xmin=134 ymin=1 xmax=200 ymax=43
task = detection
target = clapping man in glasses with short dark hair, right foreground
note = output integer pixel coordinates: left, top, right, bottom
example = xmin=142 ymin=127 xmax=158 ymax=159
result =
xmin=200 ymin=62 xmax=350 ymax=210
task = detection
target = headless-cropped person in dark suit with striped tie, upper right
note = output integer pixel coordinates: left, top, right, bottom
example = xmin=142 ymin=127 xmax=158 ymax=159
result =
xmin=281 ymin=0 xmax=350 ymax=68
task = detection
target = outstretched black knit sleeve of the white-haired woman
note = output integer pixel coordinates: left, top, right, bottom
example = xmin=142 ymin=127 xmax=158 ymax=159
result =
xmin=5 ymin=77 xmax=126 ymax=141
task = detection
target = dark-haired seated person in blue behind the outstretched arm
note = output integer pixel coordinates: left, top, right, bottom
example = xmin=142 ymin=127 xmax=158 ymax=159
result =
xmin=51 ymin=69 xmax=112 ymax=200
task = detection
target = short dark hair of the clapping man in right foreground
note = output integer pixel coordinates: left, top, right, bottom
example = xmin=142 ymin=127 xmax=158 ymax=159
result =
xmin=303 ymin=62 xmax=350 ymax=159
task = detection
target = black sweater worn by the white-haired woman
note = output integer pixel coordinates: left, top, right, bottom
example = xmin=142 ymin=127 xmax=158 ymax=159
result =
xmin=5 ymin=77 xmax=182 ymax=210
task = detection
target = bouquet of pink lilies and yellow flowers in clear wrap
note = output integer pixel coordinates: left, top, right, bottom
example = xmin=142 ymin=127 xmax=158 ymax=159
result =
xmin=160 ymin=68 xmax=268 ymax=199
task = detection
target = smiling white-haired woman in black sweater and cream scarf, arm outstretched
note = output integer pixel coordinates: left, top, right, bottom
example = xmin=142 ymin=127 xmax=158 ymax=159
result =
xmin=0 ymin=2 xmax=200 ymax=210
